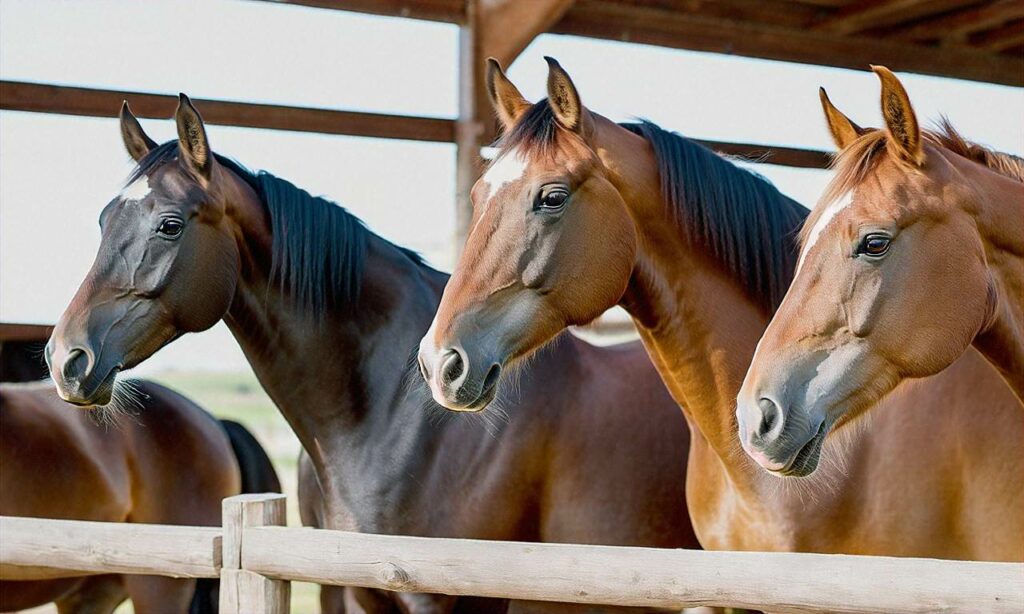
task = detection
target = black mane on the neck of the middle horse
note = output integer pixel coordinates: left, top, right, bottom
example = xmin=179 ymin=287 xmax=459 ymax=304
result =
xmin=622 ymin=121 xmax=808 ymax=313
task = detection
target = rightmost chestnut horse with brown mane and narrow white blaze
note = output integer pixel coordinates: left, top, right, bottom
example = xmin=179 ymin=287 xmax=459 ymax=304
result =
xmin=739 ymin=67 xmax=1024 ymax=445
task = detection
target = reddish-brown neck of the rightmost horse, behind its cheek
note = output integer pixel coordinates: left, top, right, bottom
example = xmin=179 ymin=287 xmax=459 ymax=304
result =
xmin=947 ymin=154 xmax=1024 ymax=400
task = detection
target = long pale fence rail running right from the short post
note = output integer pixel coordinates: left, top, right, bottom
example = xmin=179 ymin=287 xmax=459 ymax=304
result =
xmin=243 ymin=527 xmax=1024 ymax=613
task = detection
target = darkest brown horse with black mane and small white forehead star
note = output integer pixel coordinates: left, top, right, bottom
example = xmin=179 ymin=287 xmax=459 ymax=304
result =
xmin=47 ymin=96 xmax=697 ymax=612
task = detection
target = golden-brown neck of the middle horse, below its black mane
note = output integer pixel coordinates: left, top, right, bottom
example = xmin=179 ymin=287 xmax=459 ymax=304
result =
xmin=597 ymin=123 xmax=768 ymax=489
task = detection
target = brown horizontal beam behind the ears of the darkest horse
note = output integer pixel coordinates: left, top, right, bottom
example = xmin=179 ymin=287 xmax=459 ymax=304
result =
xmin=0 ymin=81 xmax=455 ymax=142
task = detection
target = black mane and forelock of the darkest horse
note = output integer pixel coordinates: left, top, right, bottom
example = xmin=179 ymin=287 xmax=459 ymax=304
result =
xmin=127 ymin=140 xmax=423 ymax=317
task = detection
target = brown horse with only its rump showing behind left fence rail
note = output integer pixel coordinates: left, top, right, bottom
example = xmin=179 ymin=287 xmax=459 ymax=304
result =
xmin=0 ymin=382 xmax=242 ymax=614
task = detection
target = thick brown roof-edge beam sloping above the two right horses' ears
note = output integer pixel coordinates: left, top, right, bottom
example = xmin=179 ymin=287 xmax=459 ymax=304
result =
xmin=553 ymin=0 xmax=1024 ymax=86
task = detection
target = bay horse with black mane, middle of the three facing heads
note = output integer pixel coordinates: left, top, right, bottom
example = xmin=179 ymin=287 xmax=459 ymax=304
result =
xmin=420 ymin=59 xmax=1024 ymax=560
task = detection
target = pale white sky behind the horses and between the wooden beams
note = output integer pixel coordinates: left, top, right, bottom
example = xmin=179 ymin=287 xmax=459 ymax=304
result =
xmin=0 ymin=0 xmax=1024 ymax=374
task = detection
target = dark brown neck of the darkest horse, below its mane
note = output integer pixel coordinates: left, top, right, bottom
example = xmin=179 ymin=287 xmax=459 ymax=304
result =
xmin=218 ymin=172 xmax=444 ymax=503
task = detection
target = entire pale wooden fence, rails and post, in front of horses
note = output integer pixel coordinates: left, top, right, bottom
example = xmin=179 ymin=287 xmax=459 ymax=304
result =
xmin=0 ymin=494 xmax=1024 ymax=614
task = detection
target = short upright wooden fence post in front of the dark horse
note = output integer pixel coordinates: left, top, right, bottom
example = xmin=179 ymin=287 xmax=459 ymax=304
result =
xmin=220 ymin=493 xmax=292 ymax=614
